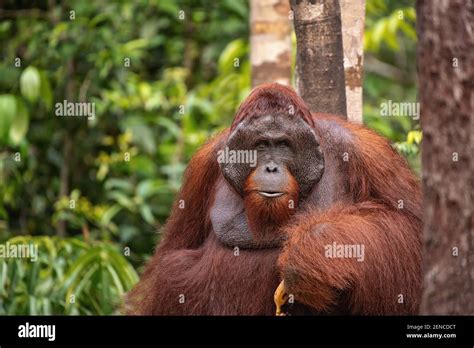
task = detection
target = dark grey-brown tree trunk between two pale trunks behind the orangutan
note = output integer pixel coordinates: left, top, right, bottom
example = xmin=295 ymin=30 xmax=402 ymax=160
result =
xmin=291 ymin=0 xmax=346 ymax=117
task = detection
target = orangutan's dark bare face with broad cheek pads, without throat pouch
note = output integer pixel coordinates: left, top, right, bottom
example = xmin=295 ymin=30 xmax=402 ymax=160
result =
xmin=221 ymin=115 xmax=324 ymax=198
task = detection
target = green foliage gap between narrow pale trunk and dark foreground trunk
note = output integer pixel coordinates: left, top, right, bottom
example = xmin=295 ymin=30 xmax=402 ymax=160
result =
xmin=363 ymin=0 xmax=421 ymax=172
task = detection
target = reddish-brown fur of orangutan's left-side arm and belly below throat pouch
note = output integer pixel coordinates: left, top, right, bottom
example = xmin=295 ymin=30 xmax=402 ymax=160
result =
xmin=126 ymin=132 xmax=279 ymax=315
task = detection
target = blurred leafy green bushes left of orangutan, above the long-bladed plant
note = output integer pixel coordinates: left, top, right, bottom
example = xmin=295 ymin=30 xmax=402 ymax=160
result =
xmin=0 ymin=0 xmax=250 ymax=246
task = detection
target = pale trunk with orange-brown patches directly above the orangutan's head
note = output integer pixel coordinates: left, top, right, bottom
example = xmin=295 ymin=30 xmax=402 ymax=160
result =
xmin=250 ymin=0 xmax=291 ymax=87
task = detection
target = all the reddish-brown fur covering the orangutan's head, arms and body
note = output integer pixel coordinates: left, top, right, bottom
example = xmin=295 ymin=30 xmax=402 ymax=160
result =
xmin=127 ymin=84 xmax=421 ymax=315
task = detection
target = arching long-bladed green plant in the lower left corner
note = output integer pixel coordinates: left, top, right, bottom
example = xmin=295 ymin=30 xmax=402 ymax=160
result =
xmin=0 ymin=236 xmax=138 ymax=315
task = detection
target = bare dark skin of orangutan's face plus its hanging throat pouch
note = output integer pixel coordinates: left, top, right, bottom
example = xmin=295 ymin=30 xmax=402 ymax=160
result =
xmin=211 ymin=114 xmax=324 ymax=248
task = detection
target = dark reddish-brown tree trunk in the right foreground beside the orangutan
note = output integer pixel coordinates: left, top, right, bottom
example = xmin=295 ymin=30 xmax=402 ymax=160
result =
xmin=417 ymin=0 xmax=474 ymax=315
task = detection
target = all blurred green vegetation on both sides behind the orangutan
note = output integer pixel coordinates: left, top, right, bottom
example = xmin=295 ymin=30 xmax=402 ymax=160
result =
xmin=0 ymin=0 xmax=421 ymax=314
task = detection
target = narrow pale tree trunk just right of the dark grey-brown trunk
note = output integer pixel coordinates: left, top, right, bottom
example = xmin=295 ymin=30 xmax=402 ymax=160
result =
xmin=341 ymin=0 xmax=365 ymax=123
